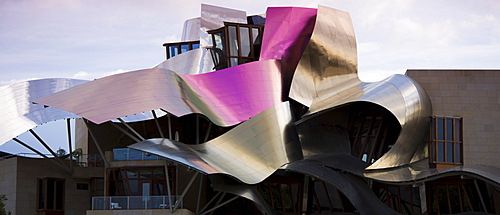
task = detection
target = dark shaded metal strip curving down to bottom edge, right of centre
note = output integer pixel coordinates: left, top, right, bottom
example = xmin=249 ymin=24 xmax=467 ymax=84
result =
xmin=282 ymin=158 xmax=399 ymax=215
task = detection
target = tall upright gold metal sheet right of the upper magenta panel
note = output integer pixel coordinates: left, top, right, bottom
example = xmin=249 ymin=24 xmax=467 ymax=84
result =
xmin=289 ymin=6 xmax=359 ymax=106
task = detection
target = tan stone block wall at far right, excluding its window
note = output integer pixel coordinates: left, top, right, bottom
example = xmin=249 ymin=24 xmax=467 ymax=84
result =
xmin=406 ymin=70 xmax=500 ymax=167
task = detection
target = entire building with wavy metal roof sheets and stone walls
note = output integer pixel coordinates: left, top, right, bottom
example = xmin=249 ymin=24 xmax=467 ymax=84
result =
xmin=0 ymin=5 xmax=500 ymax=215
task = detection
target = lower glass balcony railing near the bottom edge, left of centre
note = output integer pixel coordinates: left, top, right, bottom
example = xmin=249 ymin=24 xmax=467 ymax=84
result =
xmin=92 ymin=196 xmax=183 ymax=210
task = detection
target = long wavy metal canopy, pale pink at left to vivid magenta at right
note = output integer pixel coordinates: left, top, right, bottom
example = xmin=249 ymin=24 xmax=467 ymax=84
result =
xmin=35 ymin=60 xmax=281 ymax=126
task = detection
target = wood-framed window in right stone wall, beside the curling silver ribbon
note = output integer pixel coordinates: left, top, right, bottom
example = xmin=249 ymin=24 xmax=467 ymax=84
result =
xmin=429 ymin=117 xmax=463 ymax=165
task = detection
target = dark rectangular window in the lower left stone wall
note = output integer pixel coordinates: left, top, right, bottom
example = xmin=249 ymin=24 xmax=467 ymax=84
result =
xmin=37 ymin=178 xmax=64 ymax=214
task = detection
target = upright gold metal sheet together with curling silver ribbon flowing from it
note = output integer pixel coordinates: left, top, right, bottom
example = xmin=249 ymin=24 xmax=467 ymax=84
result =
xmin=290 ymin=6 xmax=432 ymax=169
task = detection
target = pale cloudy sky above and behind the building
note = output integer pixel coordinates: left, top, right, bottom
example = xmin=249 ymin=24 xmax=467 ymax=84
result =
xmin=0 ymin=0 xmax=500 ymax=153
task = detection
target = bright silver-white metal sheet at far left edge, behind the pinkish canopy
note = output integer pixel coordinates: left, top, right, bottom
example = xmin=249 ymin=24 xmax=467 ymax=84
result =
xmin=0 ymin=78 xmax=87 ymax=145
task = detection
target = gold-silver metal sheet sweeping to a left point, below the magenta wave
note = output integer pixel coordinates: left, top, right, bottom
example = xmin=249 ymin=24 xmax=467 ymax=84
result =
xmin=129 ymin=102 xmax=302 ymax=184
